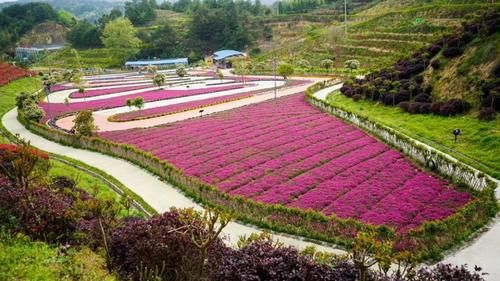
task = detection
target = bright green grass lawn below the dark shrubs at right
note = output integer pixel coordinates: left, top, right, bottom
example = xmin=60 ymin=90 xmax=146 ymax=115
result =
xmin=327 ymin=92 xmax=500 ymax=179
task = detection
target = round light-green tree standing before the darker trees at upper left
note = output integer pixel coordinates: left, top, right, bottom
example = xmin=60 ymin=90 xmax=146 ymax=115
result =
xmin=101 ymin=18 xmax=142 ymax=62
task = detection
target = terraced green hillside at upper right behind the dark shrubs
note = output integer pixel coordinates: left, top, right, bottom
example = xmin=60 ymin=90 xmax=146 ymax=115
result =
xmin=255 ymin=1 xmax=499 ymax=72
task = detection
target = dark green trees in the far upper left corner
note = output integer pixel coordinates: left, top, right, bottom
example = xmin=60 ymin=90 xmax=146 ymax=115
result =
xmin=0 ymin=3 xmax=71 ymax=51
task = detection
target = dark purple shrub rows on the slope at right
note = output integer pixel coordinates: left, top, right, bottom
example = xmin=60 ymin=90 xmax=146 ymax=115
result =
xmin=340 ymin=11 xmax=500 ymax=116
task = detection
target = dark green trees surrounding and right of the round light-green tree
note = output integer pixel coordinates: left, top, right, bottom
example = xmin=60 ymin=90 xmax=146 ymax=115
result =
xmin=68 ymin=0 xmax=263 ymax=61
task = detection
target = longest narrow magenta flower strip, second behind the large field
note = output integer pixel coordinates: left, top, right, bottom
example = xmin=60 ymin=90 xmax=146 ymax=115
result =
xmin=40 ymin=82 xmax=247 ymax=119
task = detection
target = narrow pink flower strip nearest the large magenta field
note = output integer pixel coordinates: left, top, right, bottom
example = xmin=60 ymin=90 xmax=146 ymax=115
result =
xmin=110 ymin=93 xmax=253 ymax=122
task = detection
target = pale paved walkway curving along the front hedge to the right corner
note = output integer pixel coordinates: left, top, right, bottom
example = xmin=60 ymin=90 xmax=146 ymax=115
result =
xmin=6 ymin=72 xmax=500 ymax=281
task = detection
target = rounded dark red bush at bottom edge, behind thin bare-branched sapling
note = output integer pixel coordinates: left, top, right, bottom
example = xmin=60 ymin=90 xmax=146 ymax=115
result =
xmin=109 ymin=211 xmax=228 ymax=280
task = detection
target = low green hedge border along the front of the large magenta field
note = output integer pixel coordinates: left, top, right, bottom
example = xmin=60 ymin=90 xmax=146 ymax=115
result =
xmin=18 ymin=80 xmax=498 ymax=261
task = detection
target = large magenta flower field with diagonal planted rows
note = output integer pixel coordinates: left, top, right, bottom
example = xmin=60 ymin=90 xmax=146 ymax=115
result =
xmin=101 ymin=95 xmax=472 ymax=231
